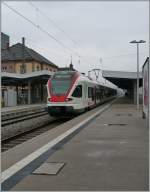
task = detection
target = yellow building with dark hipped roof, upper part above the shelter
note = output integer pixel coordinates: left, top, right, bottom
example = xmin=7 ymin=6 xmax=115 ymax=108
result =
xmin=1 ymin=35 xmax=58 ymax=73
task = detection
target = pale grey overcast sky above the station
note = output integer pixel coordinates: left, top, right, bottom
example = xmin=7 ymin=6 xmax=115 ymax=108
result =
xmin=2 ymin=1 xmax=149 ymax=77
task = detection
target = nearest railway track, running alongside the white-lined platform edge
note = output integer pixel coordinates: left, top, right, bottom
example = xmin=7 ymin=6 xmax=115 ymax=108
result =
xmin=1 ymin=119 xmax=68 ymax=152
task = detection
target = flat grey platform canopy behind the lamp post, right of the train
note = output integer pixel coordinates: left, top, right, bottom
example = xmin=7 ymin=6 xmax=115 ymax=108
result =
xmin=102 ymin=70 xmax=142 ymax=90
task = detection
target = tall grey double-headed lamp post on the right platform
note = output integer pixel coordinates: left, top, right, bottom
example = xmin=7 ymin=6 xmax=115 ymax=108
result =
xmin=130 ymin=40 xmax=146 ymax=109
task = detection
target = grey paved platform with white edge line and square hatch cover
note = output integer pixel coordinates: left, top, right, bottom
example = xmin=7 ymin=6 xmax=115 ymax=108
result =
xmin=2 ymin=98 xmax=149 ymax=191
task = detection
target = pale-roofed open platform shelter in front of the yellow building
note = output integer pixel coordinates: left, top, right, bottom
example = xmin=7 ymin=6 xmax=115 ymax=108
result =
xmin=1 ymin=70 xmax=53 ymax=107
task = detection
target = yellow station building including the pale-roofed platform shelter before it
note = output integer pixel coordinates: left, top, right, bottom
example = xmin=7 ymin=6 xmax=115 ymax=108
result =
xmin=1 ymin=33 xmax=58 ymax=106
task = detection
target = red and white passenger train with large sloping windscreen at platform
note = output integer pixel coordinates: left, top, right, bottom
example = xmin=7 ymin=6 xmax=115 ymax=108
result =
xmin=47 ymin=71 xmax=117 ymax=116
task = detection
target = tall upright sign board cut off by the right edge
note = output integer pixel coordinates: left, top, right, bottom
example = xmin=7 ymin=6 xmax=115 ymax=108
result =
xmin=143 ymin=59 xmax=150 ymax=118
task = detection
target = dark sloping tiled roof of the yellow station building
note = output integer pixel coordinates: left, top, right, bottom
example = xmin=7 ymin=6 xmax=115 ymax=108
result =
xmin=1 ymin=43 xmax=58 ymax=68
